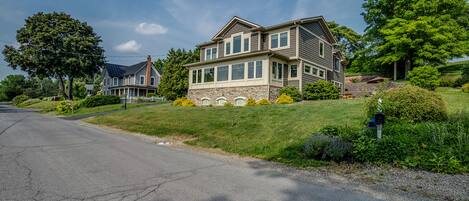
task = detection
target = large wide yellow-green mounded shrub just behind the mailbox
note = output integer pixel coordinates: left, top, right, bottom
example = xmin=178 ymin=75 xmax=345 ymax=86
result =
xmin=366 ymin=86 xmax=448 ymax=122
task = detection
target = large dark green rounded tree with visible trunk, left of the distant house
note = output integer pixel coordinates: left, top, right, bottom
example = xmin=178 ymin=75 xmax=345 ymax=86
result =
xmin=3 ymin=12 xmax=104 ymax=99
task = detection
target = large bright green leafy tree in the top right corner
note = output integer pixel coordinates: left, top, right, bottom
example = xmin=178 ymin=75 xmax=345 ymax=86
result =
xmin=363 ymin=0 xmax=469 ymax=75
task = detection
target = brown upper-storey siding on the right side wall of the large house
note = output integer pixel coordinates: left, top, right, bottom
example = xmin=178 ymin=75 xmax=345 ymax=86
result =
xmin=299 ymin=28 xmax=332 ymax=69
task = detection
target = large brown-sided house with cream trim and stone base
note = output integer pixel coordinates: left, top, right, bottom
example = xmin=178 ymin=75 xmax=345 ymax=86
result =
xmin=186 ymin=16 xmax=344 ymax=105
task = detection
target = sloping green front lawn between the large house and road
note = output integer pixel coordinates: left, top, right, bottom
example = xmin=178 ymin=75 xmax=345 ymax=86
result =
xmin=87 ymin=99 xmax=364 ymax=166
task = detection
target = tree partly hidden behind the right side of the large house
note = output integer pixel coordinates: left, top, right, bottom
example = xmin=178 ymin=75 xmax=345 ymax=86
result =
xmin=327 ymin=21 xmax=363 ymax=66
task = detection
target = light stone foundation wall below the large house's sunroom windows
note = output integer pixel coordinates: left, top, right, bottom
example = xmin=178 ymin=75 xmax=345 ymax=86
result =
xmin=187 ymin=85 xmax=274 ymax=105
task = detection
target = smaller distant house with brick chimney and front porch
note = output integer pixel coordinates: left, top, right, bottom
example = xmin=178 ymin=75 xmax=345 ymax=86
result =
xmin=103 ymin=56 xmax=161 ymax=98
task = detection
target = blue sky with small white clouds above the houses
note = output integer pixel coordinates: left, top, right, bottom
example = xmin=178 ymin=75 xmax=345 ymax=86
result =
xmin=0 ymin=0 xmax=365 ymax=80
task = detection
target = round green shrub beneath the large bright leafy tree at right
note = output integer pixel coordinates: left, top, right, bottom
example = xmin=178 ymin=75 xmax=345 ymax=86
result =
xmin=409 ymin=66 xmax=440 ymax=90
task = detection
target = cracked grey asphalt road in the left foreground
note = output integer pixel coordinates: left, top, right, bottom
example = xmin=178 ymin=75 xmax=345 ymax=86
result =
xmin=0 ymin=105 xmax=392 ymax=201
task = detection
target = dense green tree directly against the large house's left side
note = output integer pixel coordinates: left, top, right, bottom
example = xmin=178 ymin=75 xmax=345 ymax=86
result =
xmin=158 ymin=49 xmax=200 ymax=100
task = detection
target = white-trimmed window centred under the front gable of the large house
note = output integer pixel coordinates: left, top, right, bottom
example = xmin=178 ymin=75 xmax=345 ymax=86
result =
xmin=225 ymin=32 xmax=251 ymax=56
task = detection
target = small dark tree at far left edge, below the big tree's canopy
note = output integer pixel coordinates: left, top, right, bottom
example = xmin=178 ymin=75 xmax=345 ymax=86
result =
xmin=0 ymin=75 xmax=26 ymax=101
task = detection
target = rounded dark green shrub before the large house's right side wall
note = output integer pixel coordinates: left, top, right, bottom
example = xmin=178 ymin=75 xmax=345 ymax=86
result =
xmin=303 ymin=80 xmax=340 ymax=100
